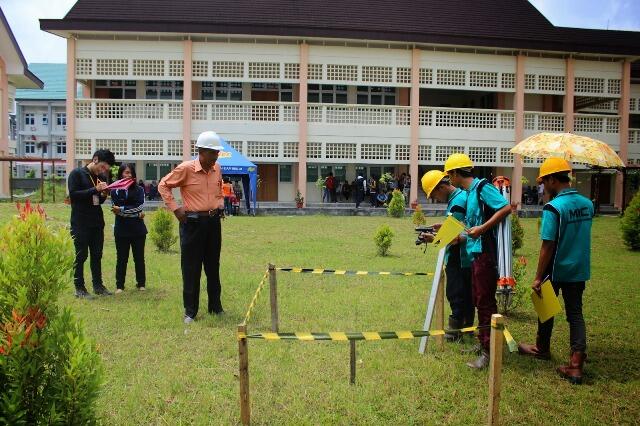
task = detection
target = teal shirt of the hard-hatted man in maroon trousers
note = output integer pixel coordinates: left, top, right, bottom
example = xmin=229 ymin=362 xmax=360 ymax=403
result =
xmin=465 ymin=178 xmax=509 ymax=259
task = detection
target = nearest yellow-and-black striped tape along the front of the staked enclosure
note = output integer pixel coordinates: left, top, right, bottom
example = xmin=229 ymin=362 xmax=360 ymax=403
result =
xmin=238 ymin=326 xmax=518 ymax=352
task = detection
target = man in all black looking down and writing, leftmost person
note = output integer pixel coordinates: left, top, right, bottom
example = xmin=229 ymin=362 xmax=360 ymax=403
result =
xmin=68 ymin=149 xmax=115 ymax=298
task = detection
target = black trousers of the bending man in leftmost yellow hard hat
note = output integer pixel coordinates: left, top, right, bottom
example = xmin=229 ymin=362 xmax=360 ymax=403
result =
xmin=445 ymin=262 xmax=475 ymax=327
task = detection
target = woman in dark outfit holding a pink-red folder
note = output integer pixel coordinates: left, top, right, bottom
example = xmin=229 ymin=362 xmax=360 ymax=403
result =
xmin=111 ymin=164 xmax=147 ymax=293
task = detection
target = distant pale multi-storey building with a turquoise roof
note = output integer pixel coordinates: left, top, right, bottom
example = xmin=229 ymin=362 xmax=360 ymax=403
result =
xmin=16 ymin=64 xmax=67 ymax=177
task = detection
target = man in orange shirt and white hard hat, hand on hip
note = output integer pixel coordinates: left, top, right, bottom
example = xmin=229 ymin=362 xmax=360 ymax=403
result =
xmin=158 ymin=132 xmax=224 ymax=324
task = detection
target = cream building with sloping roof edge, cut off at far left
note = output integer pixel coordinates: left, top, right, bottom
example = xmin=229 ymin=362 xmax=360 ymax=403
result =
xmin=0 ymin=9 xmax=42 ymax=196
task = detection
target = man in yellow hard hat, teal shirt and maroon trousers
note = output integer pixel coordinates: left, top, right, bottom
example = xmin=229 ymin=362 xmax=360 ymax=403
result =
xmin=444 ymin=154 xmax=511 ymax=369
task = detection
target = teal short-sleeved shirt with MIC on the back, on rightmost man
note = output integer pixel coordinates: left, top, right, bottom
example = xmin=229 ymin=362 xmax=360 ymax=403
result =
xmin=540 ymin=188 xmax=594 ymax=282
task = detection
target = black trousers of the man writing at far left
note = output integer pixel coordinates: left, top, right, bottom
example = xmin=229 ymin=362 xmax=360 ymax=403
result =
xmin=71 ymin=227 xmax=104 ymax=290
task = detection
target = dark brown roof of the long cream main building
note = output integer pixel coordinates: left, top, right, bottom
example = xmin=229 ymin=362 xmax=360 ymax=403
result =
xmin=41 ymin=0 xmax=640 ymax=55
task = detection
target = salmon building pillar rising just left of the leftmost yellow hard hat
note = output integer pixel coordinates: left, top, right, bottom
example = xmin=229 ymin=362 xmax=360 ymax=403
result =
xmin=409 ymin=48 xmax=420 ymax=204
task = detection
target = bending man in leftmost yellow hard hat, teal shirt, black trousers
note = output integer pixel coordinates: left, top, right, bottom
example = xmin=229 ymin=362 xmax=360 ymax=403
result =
xmin=420 ymin=170 xmax=475 ymax=341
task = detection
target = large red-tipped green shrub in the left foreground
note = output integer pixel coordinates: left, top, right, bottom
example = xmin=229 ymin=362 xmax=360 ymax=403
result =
xmin=0 ymin=203 xmax=102 ymax=424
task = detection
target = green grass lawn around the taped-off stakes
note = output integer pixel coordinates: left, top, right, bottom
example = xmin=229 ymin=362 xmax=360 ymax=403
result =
xmin=0 ymin=204 xmax=640 ymax=425
